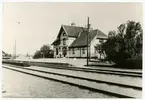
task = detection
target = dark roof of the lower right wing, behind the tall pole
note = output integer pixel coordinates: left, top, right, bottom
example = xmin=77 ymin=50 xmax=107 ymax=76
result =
xmin=70 ymin=29 xmax=107 ymax=47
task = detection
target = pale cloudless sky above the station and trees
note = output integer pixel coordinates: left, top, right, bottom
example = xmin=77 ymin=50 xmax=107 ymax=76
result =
xmin=2 ymin=2 xmax=143 ymax=54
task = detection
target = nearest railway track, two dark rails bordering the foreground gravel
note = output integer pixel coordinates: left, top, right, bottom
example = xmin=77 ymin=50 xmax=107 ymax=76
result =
xmin=3 ymin=65 xmax=142 ymax=98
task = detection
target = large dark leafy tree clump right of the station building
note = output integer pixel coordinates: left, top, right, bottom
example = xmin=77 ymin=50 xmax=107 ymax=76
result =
xmin=102 ymin=21 xmax=143 ymax=64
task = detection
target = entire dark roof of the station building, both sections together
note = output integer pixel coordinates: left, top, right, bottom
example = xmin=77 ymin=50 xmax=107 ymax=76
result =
xmin=52 ymin=25 xmax=108 ymax=47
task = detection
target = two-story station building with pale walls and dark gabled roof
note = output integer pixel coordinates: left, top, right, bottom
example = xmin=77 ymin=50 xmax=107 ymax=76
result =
xmin=52 ymin=25 xmax=108 ymax=58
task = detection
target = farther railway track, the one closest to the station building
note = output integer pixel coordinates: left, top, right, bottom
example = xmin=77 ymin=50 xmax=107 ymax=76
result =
xmin=28 ymin=62 xmax=142 ymax=77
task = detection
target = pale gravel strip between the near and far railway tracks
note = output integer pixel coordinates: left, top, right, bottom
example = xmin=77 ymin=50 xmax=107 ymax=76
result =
xmin=29 ymin=66 xmax=142 ymax=86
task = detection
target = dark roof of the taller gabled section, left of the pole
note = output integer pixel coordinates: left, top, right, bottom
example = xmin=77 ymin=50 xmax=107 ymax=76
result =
xmin=62 ymin=25 xmax=87 ymax=37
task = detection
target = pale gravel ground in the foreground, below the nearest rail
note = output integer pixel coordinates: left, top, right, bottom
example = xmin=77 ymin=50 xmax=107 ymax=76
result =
xmin=2 ymin=68 xmax=113 ymax=98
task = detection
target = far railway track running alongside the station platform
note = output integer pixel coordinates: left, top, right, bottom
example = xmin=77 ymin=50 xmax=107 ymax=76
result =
xmin=3 ymin=61 xmax=142 ymax=77
